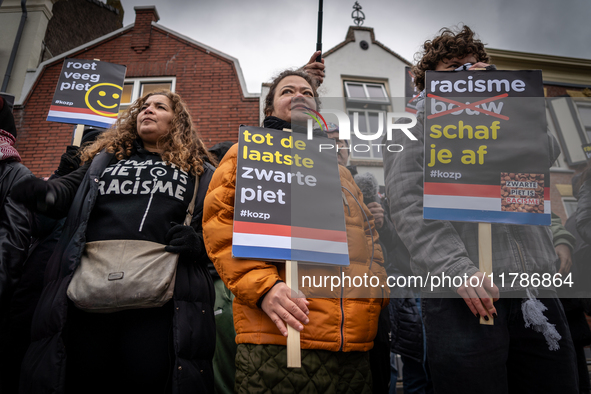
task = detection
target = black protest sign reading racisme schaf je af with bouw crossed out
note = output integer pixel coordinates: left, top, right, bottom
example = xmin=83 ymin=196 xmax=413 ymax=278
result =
xmin=424 ymin=71 xmax=551 ymax=225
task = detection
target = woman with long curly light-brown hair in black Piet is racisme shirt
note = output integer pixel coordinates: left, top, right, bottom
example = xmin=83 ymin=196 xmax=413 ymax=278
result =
xmin=14 ymin=91 xmax=215 ymax=393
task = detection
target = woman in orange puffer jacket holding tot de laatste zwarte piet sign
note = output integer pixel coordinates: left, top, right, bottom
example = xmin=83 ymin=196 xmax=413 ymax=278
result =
xmin=203 ymin=70 xmax=388 ymax=393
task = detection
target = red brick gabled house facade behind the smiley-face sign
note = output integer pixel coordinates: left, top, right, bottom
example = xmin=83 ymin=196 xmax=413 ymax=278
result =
xmin=14 ymin=6 xmax=259 ymax=176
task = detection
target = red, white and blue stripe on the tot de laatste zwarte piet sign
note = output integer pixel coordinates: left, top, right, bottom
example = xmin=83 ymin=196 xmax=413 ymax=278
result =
xmin=232 ymin=221 xmax=349 ymax=265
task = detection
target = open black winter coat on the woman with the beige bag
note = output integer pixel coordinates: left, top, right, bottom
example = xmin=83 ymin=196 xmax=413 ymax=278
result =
xmin=21 ymin=152 xmax=215 ymax=394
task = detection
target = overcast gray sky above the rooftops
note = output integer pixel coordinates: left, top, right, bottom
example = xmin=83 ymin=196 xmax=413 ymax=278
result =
xmin=122 ymin=0 xmax=591 ymax=93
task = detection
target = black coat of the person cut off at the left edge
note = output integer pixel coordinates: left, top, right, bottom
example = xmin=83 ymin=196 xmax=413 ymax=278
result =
xmin=0 ymin=160 xmax=32 ymax=321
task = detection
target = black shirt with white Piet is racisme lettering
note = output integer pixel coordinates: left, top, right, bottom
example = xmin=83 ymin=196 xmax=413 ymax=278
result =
xmin=86 ymin=145 xmax=195 ymax=244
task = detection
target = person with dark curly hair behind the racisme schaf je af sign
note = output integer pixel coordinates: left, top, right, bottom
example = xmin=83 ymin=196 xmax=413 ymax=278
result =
xmin=384 ymin=26 xmax=578 ymax=394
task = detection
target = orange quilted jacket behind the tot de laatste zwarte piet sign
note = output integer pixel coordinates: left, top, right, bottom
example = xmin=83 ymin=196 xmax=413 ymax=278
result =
xmin=203 ymin=144 xmax=388 ymax=352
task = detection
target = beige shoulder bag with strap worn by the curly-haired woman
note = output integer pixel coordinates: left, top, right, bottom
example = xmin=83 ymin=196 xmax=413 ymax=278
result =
xmin=67 ymin=177 xmax=199 ymax=313
